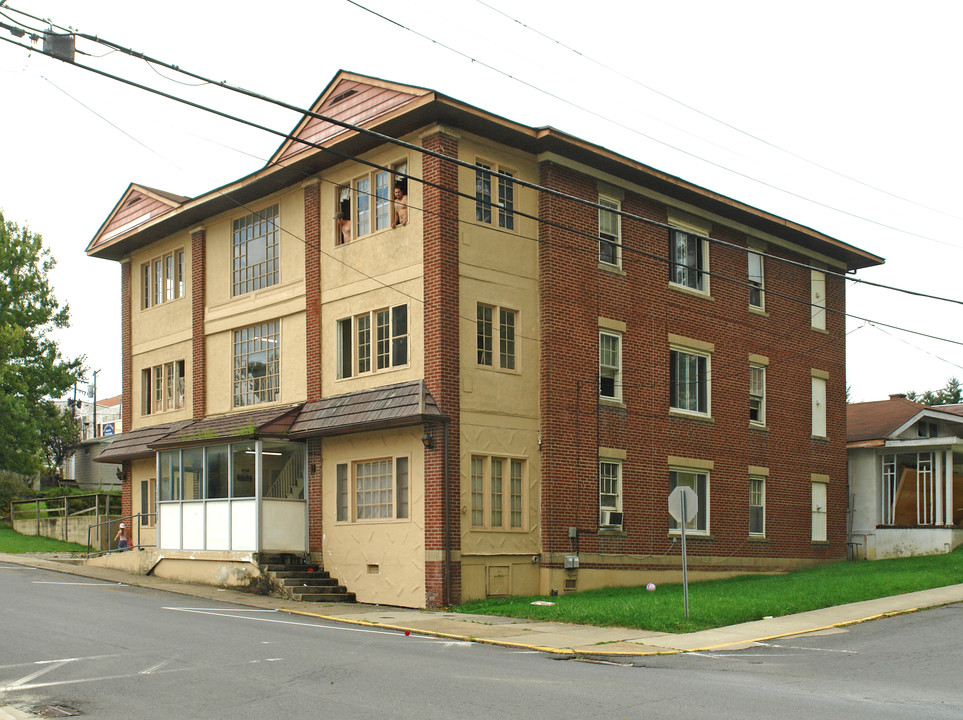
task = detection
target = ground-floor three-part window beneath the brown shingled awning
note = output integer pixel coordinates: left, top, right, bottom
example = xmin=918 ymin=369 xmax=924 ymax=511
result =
xmin=335 ymin=457 xmax=408 ymax=522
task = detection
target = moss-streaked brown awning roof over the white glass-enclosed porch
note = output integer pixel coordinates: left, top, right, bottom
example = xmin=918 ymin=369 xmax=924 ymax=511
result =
xmin=150 ymin=404 xmax=303 ymax=450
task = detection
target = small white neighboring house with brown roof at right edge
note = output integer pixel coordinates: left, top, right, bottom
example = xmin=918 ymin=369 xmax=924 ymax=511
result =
xmin=846 ymin=395 xmax=963 ymax=560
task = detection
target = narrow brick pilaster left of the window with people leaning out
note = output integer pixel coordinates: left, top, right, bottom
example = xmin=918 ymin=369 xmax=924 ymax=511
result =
xmin=304 ymin=180 xmax=321 ymax=402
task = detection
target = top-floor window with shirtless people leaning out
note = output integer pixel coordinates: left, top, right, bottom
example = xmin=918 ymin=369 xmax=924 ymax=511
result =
xmin=335 ymin=162 xmax=408 ymax=245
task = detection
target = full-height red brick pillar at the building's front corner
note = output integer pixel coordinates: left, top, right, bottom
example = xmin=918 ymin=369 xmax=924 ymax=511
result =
xmin=423 ymin=132 xmax=461 ymax=607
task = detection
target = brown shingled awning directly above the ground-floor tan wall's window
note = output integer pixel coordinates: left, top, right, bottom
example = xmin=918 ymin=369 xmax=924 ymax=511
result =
xmin=289 ymin=380 xmax=448 ymax=438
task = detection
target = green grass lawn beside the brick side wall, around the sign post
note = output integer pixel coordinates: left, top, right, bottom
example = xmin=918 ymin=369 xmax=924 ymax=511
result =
xmin=454 ymin=548 xmax=963 ymax=632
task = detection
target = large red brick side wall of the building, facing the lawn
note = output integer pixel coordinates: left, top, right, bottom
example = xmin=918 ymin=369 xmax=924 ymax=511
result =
xmin=539 ymin=163 xmax=846 ymax=567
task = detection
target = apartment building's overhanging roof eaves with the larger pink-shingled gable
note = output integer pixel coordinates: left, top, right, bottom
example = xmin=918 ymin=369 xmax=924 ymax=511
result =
xmin=87 ymin=70 xmax=883 ymax=270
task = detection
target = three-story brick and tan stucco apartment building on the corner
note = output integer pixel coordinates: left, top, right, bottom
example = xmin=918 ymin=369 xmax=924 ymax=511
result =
xmin=87 ymin=72 xmax=882 ymax=607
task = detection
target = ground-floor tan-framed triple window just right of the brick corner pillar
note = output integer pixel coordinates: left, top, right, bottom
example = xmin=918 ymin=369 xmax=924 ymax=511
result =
xmin=471 ymin=456 xmax=525 ymax=530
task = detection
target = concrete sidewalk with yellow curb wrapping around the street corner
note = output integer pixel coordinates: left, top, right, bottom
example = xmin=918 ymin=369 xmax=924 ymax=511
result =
xmin=7 ymin=553 xmax=963 ymax=657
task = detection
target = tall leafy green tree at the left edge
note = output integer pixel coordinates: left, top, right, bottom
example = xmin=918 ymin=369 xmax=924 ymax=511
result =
xmin=0 ymin=212 xmax=84 ymax=475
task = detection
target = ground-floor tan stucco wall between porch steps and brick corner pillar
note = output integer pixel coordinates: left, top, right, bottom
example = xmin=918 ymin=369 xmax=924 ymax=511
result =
xmin=321 ymin=425 xmax=425 ymax=607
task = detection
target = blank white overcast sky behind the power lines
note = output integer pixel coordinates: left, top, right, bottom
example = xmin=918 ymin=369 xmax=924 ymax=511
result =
xmin=0 ymin=0 xmax=963 ymax=401
